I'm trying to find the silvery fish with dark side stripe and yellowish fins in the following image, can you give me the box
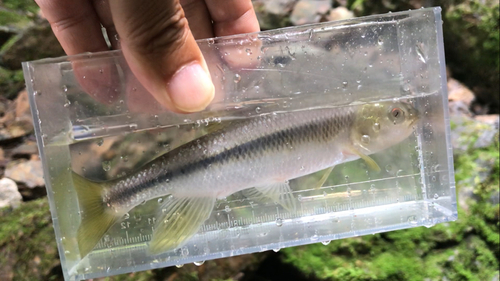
[72,101,419,257]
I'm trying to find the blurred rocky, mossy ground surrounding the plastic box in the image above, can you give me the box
[0,0,500,281]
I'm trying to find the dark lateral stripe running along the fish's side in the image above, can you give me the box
[106,109,355,202]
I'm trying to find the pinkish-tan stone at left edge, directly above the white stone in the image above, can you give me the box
[5,159,45,188]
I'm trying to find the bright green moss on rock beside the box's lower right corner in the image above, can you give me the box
[282,131,500,281]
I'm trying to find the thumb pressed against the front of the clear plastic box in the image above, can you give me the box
[109,0,214,112]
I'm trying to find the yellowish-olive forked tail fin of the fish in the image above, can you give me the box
[73,172,120,258]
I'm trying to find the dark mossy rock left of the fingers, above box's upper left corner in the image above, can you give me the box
[0,20,64,70]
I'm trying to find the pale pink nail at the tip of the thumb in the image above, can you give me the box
[167,63,215,112]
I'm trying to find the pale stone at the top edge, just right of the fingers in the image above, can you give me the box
[290,0,332,25]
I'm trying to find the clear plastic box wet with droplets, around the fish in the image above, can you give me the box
[23,8,457,280]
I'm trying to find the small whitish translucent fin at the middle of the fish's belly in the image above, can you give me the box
[246,182,296,212]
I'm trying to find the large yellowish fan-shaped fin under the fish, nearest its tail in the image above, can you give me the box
[149,197,215,254]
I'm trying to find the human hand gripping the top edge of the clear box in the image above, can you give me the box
[35,0,259,112]
